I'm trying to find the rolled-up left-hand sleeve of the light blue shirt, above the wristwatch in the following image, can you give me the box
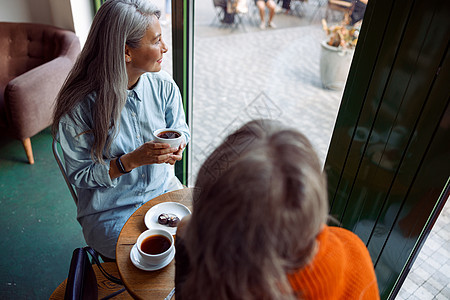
[59,122,118,189]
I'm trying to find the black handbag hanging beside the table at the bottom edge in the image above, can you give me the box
[64,247,125,300]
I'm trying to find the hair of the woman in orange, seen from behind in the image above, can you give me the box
[177,120,328,300]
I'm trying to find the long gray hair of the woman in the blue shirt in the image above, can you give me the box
[52,0,161,163]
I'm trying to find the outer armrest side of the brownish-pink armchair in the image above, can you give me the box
[4,56,73,140]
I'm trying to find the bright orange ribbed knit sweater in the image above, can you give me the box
[288,226,380,300]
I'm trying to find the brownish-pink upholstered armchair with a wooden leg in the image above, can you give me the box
[0,22,80,164]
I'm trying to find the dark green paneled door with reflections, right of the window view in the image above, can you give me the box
[325,0,450,299]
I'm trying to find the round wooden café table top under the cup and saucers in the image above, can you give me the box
[116,188,193,300]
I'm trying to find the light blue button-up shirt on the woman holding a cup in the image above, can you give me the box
[59,71,190,258]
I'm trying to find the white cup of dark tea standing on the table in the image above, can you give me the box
[136,228,175,265]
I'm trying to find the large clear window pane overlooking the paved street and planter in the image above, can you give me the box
[190,0,366,179]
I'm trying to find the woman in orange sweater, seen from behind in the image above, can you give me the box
[175,120,379,300]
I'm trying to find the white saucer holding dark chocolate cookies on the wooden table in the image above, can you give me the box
[144,202,191,235]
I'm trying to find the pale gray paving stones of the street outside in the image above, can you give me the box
[156,0,450,300]
